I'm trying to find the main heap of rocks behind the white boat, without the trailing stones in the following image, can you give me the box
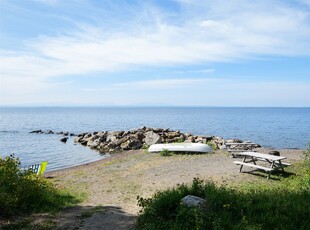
[74,127,224,153]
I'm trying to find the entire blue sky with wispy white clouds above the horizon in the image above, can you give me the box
[0,0,310,107]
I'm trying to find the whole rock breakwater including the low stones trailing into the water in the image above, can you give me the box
[30,127,261,153]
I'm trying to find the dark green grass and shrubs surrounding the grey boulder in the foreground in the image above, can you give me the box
[136,146,310,229]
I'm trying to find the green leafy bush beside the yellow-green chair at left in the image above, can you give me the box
[0,155,79,217]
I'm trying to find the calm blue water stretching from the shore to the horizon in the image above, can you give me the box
[0,107,310,171]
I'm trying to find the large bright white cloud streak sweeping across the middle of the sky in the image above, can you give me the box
[1,1,310,81]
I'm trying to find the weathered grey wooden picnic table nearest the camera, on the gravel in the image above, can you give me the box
[234,152,291,179]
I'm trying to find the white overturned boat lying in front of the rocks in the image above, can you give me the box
[148,143,213,153]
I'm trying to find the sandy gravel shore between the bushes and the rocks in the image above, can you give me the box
[38,149,302,229]
